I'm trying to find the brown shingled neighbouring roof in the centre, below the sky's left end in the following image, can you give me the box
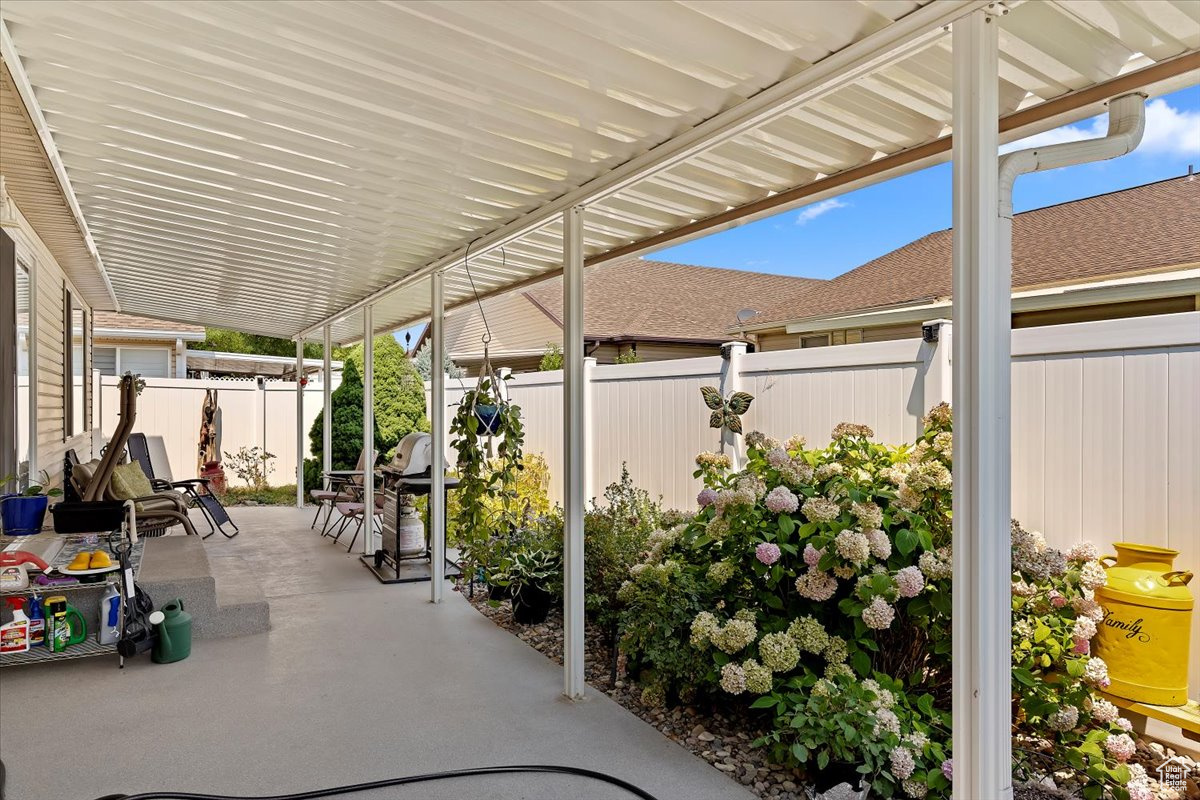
[524,258,824,341]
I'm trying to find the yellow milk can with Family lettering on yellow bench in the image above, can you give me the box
[1094,543,1193,705]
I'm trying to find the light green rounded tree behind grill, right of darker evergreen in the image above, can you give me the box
[333,335,430,455]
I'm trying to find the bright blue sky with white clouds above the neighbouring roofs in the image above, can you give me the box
[648,86,1200,278]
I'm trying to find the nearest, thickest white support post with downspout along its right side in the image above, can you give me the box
[952,11,1013,800]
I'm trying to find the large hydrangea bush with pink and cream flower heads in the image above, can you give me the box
[619,404,1147,800]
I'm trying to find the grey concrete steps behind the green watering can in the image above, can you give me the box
[138,536,271,639]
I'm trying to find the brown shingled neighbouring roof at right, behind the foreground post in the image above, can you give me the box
[734,176,1200,329]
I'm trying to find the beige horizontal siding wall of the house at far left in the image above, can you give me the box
[11,200,92,485]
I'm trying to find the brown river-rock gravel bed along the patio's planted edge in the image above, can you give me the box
[460,587,1200,800]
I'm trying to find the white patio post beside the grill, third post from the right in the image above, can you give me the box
[430,272,446,603]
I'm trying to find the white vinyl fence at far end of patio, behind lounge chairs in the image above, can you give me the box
[97,375,331,486]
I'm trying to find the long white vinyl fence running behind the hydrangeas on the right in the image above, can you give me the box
[436,313,1200,700]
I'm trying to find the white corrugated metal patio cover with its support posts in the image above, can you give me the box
[0,0,1200,798]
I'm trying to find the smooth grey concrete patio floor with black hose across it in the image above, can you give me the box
[0,507,752,800]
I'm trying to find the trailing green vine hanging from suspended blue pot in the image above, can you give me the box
[450,374,524,578]
